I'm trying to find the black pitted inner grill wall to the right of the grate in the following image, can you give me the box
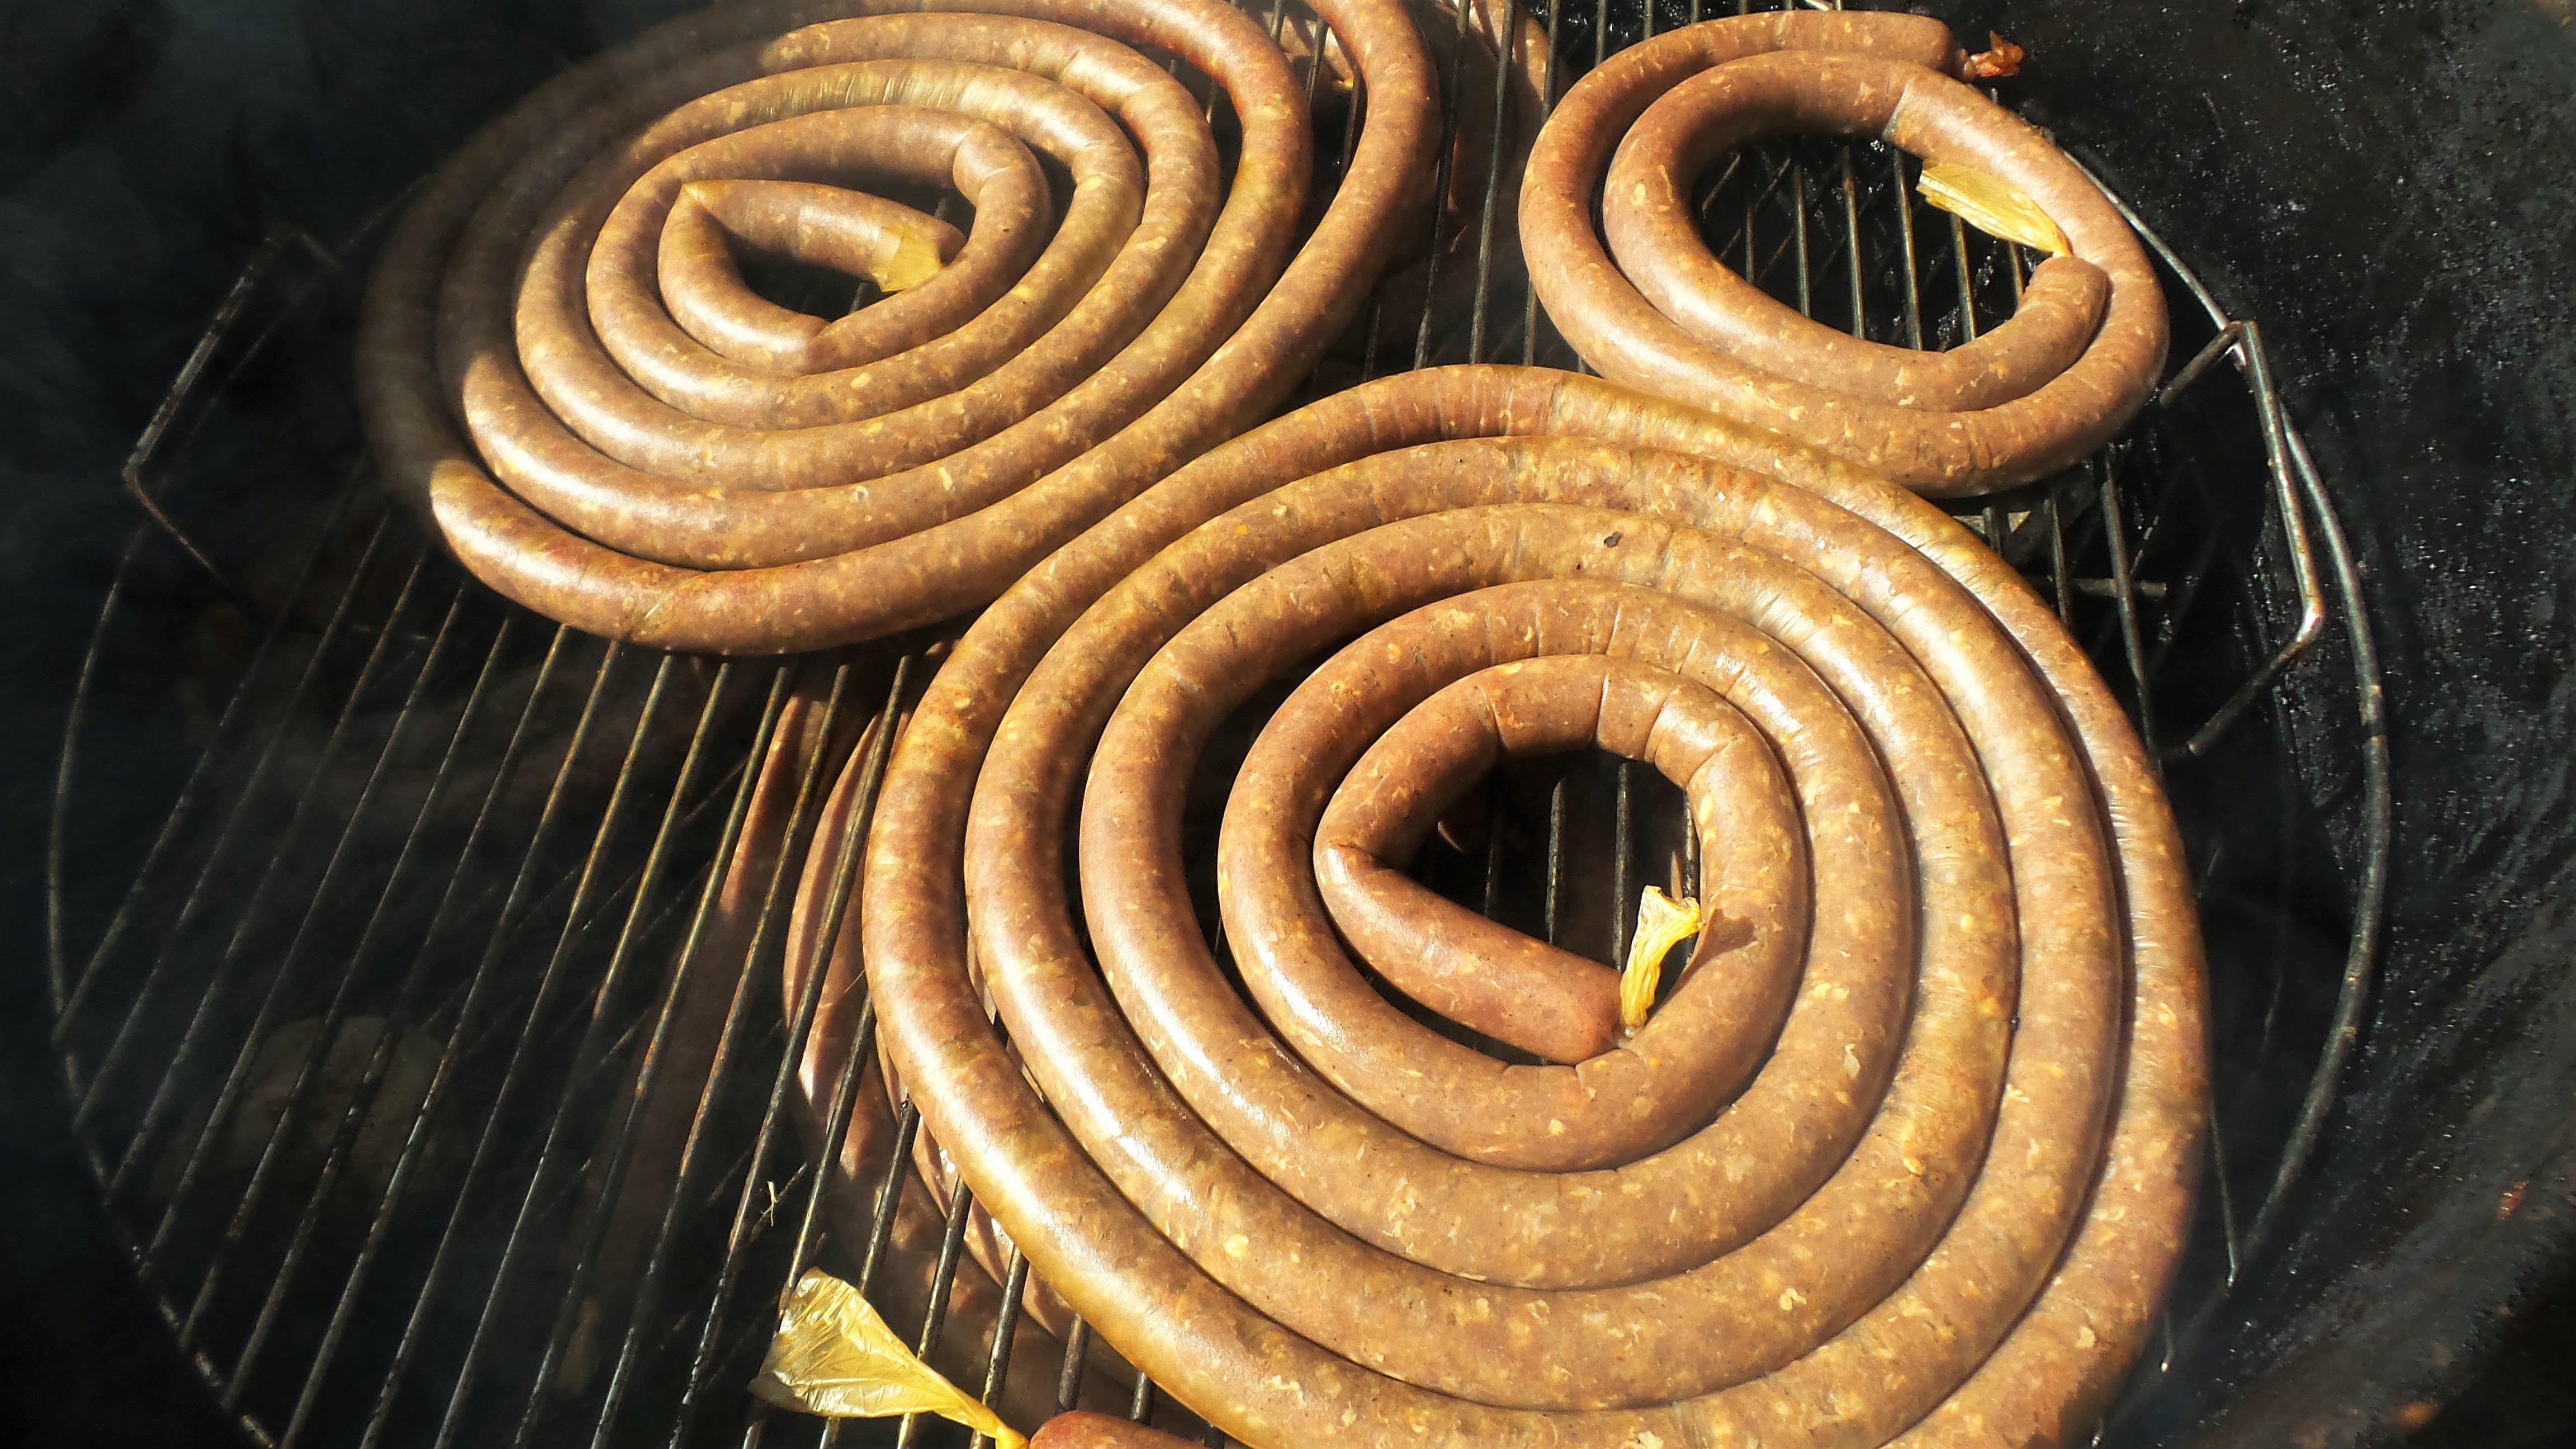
[1924,0,2576,1446]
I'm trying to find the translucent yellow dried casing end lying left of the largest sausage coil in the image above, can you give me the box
[752,1268,1028,1449]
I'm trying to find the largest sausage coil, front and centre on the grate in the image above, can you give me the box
[858,366,2205,1449]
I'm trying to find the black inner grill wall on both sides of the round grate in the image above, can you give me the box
[0,0,2576,1446]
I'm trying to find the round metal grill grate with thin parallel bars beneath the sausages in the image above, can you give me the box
[49,0,2388,1449]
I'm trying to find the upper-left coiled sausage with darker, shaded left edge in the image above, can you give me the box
[358,0,1437,652]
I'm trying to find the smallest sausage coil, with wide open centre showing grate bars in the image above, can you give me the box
[1520,10,2166,498]
